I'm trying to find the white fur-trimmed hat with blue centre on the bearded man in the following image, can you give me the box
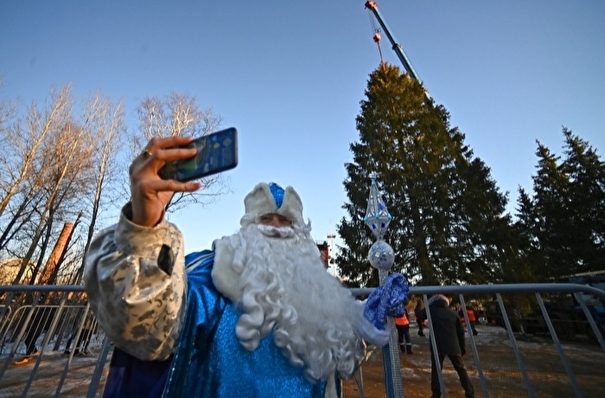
[244,182,303,224]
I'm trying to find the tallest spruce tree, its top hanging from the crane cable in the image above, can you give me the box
[337,64,510,286]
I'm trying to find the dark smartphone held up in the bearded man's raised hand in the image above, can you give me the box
[159,127,237,182]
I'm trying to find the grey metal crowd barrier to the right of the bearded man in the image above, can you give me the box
[352,283,605,398]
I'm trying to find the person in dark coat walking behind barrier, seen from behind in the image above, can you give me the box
[424,294,475,398]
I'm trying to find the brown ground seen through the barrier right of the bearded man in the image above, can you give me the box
[343,326,605,398]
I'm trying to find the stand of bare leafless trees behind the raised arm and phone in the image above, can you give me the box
[0,85,225,290]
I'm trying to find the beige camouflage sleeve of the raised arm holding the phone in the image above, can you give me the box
[84,205,186,360]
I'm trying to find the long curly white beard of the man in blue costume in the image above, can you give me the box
[232,223,364,381]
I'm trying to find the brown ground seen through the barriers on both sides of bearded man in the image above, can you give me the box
[0,326,605,398]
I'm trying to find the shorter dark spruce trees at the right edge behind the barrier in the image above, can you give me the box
[517,129,605,281]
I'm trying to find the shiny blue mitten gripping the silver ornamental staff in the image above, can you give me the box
[363,272,410,330]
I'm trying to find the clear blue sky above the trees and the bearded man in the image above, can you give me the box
[0,0,605,251]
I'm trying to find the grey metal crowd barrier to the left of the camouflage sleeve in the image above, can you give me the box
[0,285,109,398]
